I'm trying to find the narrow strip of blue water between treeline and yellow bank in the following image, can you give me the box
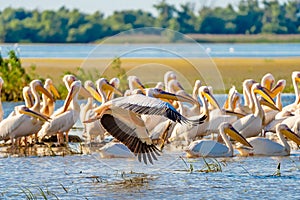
[0,43,300,58]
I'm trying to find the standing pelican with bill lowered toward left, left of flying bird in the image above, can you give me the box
[38,81,82,144]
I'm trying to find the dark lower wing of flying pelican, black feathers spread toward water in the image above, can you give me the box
[101,114,160,164]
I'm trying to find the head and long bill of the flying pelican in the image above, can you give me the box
[146,88,197,104]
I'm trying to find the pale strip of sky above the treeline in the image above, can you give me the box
[0,0,286,16]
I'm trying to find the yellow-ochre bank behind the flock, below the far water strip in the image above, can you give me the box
[21,57,300,93]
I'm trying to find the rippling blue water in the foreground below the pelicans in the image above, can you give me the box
[0,94,300,199]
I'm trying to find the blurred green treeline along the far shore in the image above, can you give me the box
[0,0,300,43]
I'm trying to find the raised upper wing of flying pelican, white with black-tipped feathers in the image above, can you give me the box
[112,94,206,125]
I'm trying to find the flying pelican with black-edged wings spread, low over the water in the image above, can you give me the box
[86,88,206,164]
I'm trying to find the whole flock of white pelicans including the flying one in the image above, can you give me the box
[0,71,300,164]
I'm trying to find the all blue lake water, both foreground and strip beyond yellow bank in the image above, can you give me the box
[0,41,300,199]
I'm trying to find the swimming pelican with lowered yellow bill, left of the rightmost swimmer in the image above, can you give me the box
[185,122,251,157]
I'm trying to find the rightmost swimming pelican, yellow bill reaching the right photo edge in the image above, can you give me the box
[237,124,300,156]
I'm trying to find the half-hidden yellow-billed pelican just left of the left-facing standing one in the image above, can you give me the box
[41,78,60,117]
